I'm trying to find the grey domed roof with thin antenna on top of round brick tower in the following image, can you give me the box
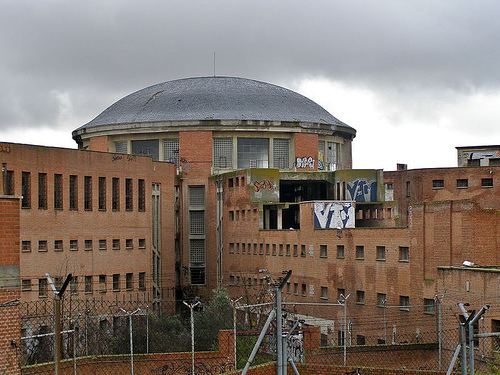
[74,77,356,135]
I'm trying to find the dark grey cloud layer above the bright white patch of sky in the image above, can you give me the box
[0,0,500,128]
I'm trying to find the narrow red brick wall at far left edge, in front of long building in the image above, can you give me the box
[0,196,21,375]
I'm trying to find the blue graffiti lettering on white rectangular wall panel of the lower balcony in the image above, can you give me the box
[314,202,355,229]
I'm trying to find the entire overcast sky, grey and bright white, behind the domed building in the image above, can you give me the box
[0,0,500,169]
